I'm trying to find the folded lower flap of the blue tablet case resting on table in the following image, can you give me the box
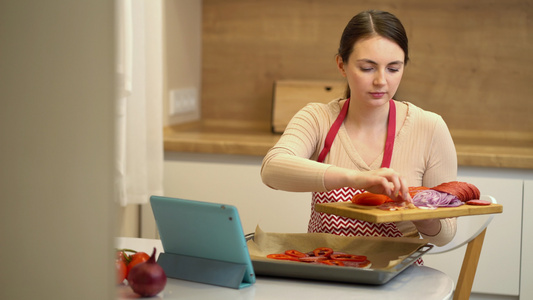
[157,252,249,289]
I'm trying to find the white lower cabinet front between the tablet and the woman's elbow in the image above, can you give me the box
[164,152,311,233]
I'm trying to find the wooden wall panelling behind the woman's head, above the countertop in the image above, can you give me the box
[202,0,533,132]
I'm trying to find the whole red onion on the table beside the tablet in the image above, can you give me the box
[128,248,167,297]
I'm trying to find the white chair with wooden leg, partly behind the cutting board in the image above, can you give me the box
[427,195,497,300]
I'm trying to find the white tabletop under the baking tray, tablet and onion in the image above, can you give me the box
[117,238,454,300]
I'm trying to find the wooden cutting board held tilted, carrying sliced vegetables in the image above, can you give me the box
[315,202,503,223]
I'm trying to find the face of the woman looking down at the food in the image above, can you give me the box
[337,36,405,106]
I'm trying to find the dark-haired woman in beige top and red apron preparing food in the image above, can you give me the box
[261,10,457,246]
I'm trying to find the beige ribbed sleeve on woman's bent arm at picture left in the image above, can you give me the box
[261,104,331,192]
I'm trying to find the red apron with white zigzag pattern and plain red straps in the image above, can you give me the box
[308,99,423,265]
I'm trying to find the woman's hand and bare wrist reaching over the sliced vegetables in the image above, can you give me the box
[325,167,412,202]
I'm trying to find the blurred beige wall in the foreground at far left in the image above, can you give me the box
[0,0,115,300]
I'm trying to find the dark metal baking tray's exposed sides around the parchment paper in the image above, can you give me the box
[246,233,433,285]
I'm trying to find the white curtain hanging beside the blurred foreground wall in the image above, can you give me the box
[115,0,163,206]
